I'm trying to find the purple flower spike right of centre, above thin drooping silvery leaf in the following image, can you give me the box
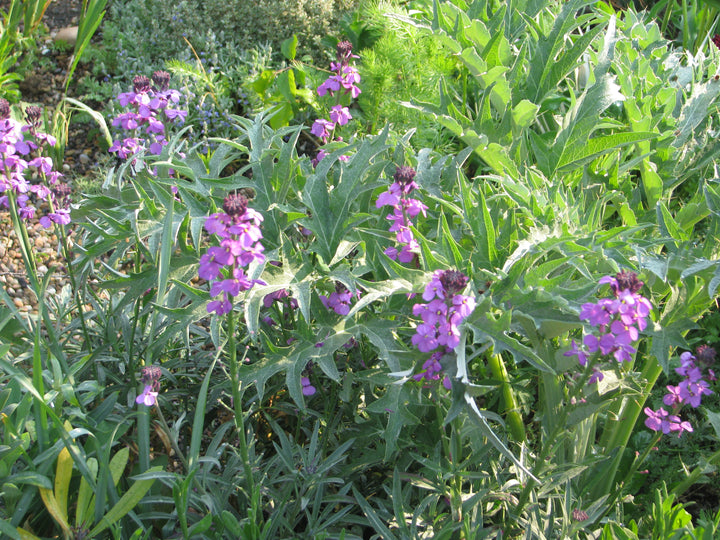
[412,270,475,387]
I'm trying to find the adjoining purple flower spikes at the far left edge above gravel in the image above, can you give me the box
[0,98,71,228]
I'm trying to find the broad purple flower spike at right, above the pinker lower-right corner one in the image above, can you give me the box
[565,271,652,384]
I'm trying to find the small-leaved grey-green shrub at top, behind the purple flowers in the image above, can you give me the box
[94,0,357,103]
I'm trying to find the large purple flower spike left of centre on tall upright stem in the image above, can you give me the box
[198,194,265,315]
